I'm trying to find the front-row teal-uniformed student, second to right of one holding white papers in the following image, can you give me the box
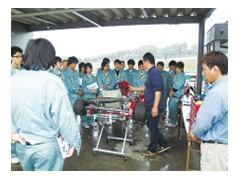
[112,59,127,88]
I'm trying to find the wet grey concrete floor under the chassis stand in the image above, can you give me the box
[11,121,200,171]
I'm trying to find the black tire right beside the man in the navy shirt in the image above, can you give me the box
[133,102,146,123]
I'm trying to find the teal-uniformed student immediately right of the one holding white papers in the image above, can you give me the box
[97,61,115,95]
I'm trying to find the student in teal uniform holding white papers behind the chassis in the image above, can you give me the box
[81,63,98,128]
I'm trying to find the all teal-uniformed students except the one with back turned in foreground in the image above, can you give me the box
[11,40,185,166]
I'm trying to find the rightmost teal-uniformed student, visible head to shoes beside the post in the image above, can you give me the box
[165,61,186,127]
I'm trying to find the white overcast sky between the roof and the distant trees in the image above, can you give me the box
[34,24,198,58]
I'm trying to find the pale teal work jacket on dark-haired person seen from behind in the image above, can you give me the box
[11,70,81,153]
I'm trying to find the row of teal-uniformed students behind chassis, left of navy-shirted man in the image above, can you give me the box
[50,56,147,128]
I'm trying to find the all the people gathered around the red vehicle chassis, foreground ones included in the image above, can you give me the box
[11,38,228,170]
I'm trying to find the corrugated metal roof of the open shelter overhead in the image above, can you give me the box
[11,8,214,31]
